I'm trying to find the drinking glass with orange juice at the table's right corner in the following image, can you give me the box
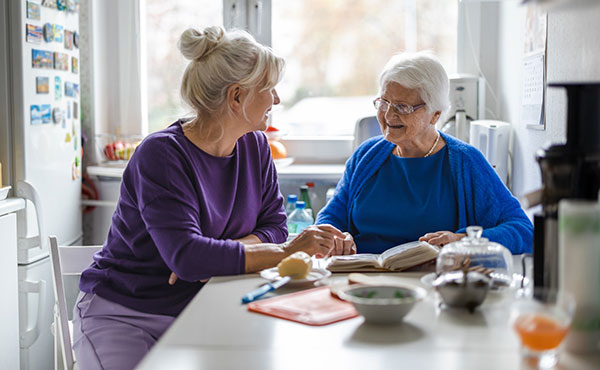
[511,288,575,369]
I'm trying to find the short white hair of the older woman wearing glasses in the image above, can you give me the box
[379,51,450,112]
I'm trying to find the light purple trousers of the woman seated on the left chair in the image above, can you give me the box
[73,292,175,370]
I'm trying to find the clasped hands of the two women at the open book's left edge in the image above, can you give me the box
[284,225,346,258]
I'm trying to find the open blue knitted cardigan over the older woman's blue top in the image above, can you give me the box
[316,133,533,254]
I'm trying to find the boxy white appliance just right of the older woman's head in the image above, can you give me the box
[441,73,485,142]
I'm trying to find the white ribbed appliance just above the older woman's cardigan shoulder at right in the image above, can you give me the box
[469,120,511,185]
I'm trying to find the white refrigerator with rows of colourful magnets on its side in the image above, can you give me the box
[0,0,82,370]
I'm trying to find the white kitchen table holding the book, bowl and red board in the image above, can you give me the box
[138,264,600,370]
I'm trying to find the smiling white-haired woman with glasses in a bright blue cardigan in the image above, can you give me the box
[317,53,533,254]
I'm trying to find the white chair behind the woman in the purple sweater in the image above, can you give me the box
[48,236,102,370]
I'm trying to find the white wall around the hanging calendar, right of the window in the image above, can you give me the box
[498,2,600,195]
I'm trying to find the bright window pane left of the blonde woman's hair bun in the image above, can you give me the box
[145,0,223,132]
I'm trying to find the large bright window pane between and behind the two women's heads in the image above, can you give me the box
[271,0,458,136]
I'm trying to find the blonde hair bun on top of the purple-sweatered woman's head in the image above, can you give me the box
[177,26,225,60]
